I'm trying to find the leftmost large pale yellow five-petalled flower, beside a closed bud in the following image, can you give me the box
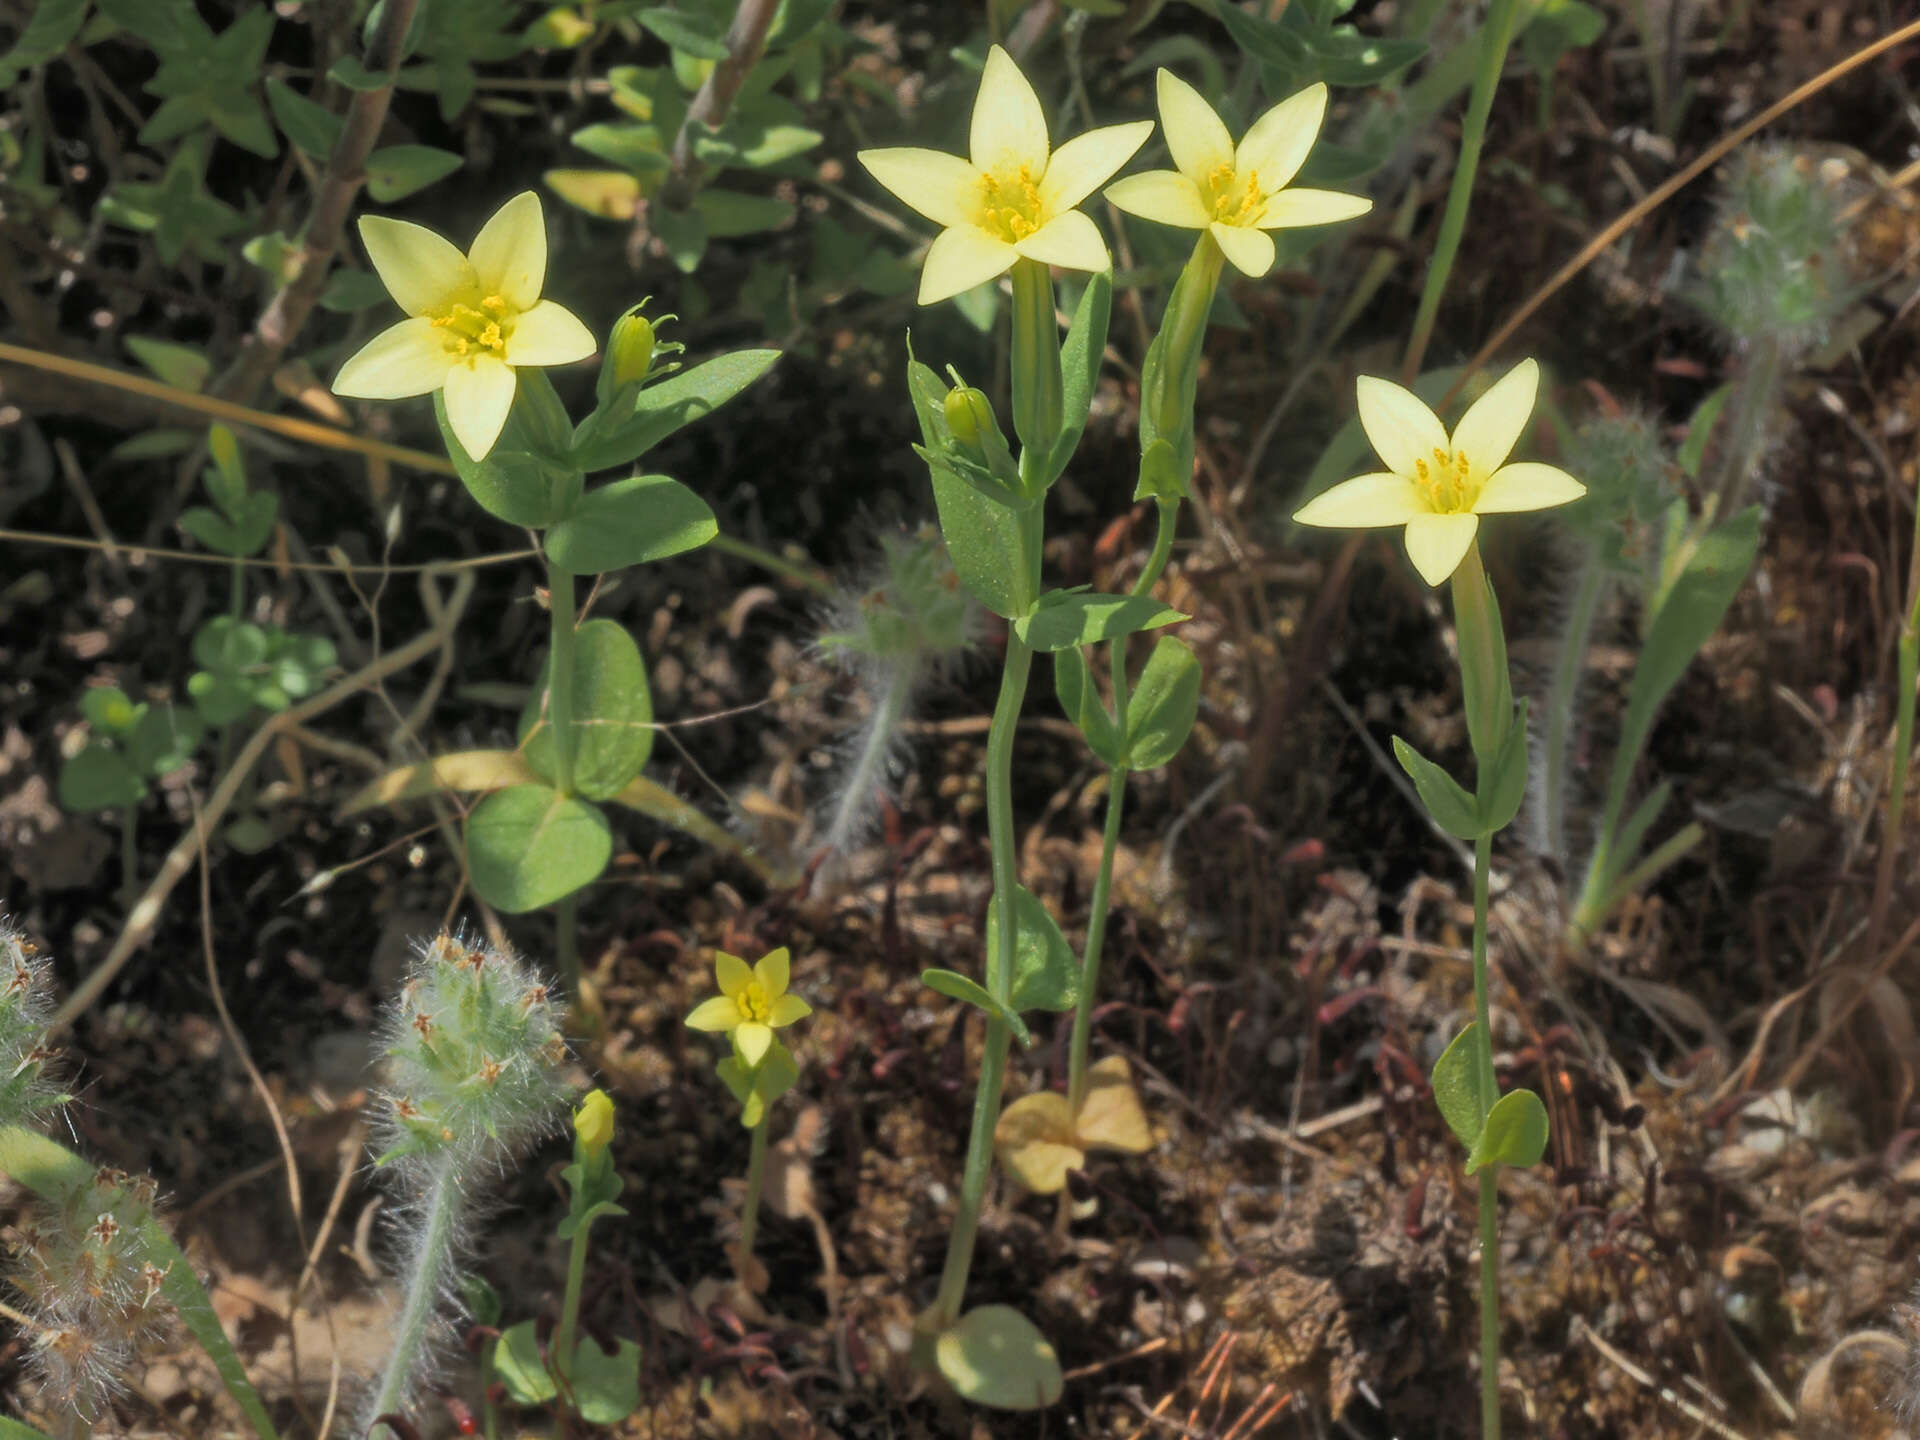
[334,190,593,459]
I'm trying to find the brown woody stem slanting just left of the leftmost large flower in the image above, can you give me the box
[213,0,417,403]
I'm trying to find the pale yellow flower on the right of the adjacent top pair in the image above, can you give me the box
[1106,69,1373,278]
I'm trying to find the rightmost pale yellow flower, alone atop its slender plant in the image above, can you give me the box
[1294,359,1586,586]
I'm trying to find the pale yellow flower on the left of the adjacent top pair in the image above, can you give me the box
[860,46,1154,305]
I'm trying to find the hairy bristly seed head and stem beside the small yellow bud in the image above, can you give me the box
[359,933,566,1440]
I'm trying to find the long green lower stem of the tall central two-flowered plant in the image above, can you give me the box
[933,634,1033,1329]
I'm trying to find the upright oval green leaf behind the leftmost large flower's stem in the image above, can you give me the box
[520,620,653,801]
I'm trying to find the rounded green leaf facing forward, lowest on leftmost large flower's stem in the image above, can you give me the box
[467,785,612,916]
